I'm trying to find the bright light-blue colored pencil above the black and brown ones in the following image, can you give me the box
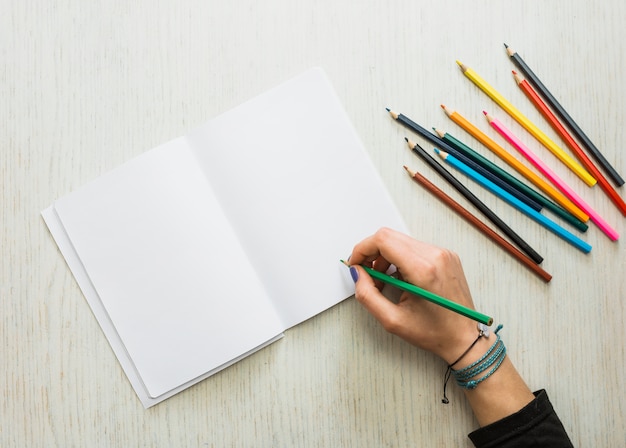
[435,149,591,253]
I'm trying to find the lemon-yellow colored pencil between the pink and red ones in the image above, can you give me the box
[456,61,596,187]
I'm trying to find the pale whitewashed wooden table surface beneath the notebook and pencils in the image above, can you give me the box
[0,0,626,447]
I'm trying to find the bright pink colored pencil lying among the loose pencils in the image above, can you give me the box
[483,111,619,241]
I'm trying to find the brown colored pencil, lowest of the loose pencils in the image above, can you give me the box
[404,166,552,283]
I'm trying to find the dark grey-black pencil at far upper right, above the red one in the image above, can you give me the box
[504,44,624,186]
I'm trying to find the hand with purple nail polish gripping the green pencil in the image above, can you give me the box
[349,228,478,364]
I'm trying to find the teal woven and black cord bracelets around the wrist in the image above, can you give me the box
[441,324,506,404]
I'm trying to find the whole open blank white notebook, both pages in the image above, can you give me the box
[42,68,405,407]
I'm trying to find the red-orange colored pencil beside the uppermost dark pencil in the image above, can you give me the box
[513,71,626,216]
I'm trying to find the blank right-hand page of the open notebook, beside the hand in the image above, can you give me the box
[188,69,406,328]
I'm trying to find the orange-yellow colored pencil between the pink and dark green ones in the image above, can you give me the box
[441,104,589,222]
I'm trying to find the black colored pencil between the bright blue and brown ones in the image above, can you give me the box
[405,138,543,264]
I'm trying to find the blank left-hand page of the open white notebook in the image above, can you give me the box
[43,138,283,407]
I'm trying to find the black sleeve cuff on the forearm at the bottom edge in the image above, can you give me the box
[469,389,573,448]
